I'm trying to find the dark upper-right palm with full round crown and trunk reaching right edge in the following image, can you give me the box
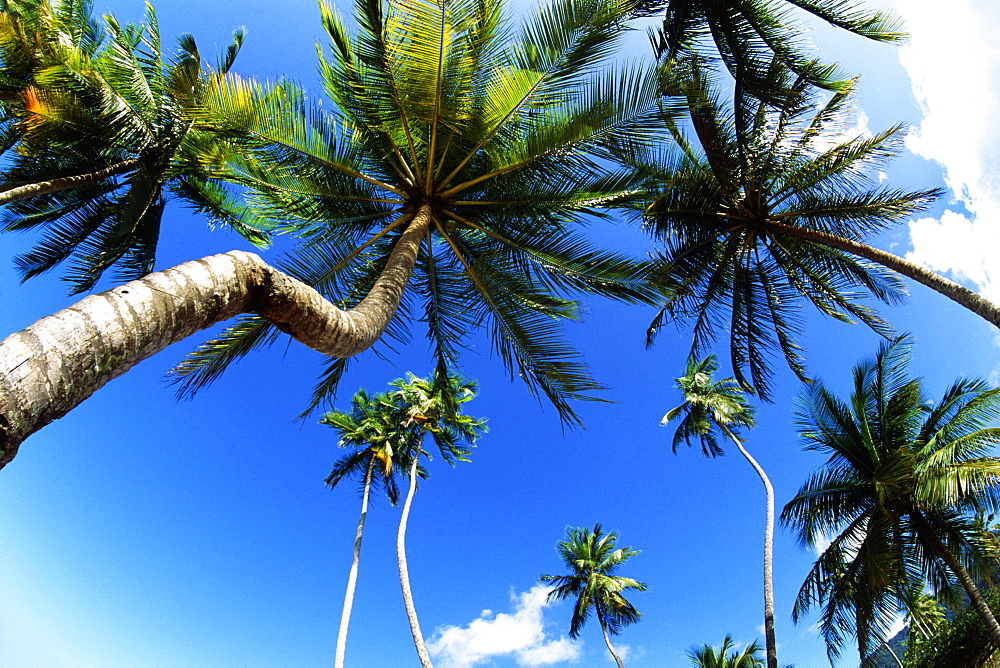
[638,59,1000,398]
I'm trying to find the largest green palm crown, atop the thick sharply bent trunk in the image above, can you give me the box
[170,0,662,420]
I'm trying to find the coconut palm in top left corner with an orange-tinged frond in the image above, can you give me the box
[0,0,273,292]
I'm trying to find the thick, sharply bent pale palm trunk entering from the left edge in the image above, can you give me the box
[0,206,430,468]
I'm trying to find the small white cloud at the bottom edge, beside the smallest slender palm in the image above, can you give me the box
[427,584,581,668]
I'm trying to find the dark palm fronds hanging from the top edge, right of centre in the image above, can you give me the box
[653,0,906,98]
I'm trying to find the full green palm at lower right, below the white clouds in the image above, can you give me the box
[781,337,1000,661]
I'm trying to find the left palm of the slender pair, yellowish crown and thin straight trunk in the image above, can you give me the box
[320,389,426,668]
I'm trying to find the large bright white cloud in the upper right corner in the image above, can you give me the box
[896,0,1000,300]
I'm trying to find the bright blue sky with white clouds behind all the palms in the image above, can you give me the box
[0,0,1000,668]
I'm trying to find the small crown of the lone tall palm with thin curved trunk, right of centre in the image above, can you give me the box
[660,355,754,457]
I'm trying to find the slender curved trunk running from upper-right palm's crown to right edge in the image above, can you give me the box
[768,222,1000,327]
